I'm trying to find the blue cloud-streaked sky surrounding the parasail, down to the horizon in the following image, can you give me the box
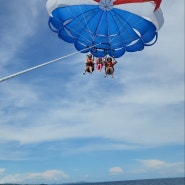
[0,0,184,184]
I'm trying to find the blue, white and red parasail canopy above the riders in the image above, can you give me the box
[46,0,164,58]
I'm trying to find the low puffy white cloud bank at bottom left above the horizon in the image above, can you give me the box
[0,170,69,183]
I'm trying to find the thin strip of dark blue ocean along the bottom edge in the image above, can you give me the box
[63,177,185,185]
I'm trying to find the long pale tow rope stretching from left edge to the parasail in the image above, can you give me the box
[0,46,97,83]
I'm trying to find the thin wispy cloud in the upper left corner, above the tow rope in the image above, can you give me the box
[0,1,44,68]
